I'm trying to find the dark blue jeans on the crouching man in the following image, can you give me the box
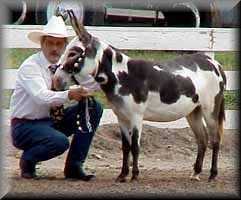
[11,99,103,164]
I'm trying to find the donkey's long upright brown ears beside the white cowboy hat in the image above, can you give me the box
[67,9,91,46]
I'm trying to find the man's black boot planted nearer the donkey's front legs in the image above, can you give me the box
[64,163,95,181]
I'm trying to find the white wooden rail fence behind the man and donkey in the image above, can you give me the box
[1,25,239,129]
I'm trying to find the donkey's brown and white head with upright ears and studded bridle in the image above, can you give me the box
[54,10,108,90]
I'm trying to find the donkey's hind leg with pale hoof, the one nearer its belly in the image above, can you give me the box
[187,107,208,181]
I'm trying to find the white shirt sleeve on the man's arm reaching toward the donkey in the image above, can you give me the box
[18,63,69,106]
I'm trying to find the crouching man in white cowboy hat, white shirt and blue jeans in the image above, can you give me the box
[10,16,102,181]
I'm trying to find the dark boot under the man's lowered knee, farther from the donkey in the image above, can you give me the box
[19,158,37,179]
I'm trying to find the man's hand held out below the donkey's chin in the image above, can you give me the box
[68,86,91,101]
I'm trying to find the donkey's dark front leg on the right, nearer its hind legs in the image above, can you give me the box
[131,127,140,181]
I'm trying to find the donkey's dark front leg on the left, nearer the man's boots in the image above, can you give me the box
[116,128,131,182]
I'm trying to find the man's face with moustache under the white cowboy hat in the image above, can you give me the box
[41,36,67,64]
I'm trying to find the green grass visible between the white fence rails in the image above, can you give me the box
[1,49,240,110]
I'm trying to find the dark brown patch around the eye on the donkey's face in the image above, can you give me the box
[63,46,83,72]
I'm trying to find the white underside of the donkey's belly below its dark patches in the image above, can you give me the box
[144,93,199,122]
